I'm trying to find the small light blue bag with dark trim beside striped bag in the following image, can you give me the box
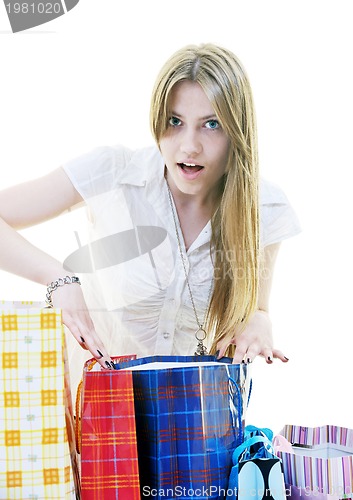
[227,425,286,500]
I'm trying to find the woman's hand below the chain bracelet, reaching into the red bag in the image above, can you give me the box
[52,283,114,370]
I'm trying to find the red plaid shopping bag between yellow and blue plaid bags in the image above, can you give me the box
[76,356,140,500]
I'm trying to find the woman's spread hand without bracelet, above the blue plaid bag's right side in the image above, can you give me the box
[217,310,288,364]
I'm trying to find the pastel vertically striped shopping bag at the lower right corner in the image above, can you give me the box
[276,425,353,500]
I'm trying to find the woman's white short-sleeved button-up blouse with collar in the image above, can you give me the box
[64,146,300,378]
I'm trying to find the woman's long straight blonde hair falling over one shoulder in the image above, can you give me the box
[150,44,259,355]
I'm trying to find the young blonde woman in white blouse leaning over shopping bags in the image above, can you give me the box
[0,44,299,386]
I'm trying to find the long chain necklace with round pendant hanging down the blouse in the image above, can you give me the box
[166,179,213,356]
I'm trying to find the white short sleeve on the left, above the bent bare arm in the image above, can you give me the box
[63,146,132,200]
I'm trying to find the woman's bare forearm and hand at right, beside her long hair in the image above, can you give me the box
[217,243,288,363]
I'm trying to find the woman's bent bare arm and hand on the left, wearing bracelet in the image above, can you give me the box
[0,168,111,368]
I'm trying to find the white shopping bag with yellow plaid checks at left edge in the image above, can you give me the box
[0,301,79,500]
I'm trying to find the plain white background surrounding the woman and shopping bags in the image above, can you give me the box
[0,0,353,432]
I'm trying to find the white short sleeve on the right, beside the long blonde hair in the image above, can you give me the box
[260,179,301,247]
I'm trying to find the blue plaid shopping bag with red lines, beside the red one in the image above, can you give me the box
[113,356,250,500]
